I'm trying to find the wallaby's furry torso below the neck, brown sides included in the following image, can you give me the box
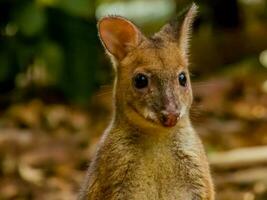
[84,126,214,200]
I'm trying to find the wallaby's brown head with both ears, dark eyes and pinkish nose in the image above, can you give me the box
[98,4,197,128]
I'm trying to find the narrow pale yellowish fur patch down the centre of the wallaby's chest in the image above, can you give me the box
[121,141,195,200]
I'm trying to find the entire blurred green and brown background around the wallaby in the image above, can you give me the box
[0,0,267,200]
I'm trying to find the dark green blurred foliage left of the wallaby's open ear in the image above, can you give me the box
[0,0,108,102]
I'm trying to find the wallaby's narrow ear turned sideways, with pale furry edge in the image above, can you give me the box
[160,3,197,58]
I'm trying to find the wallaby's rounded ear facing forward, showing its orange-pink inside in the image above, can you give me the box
[98,16,142,60]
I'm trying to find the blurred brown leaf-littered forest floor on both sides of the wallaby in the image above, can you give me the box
[0,61,267,200]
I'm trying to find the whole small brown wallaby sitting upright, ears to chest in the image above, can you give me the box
[79,4,214,200]
